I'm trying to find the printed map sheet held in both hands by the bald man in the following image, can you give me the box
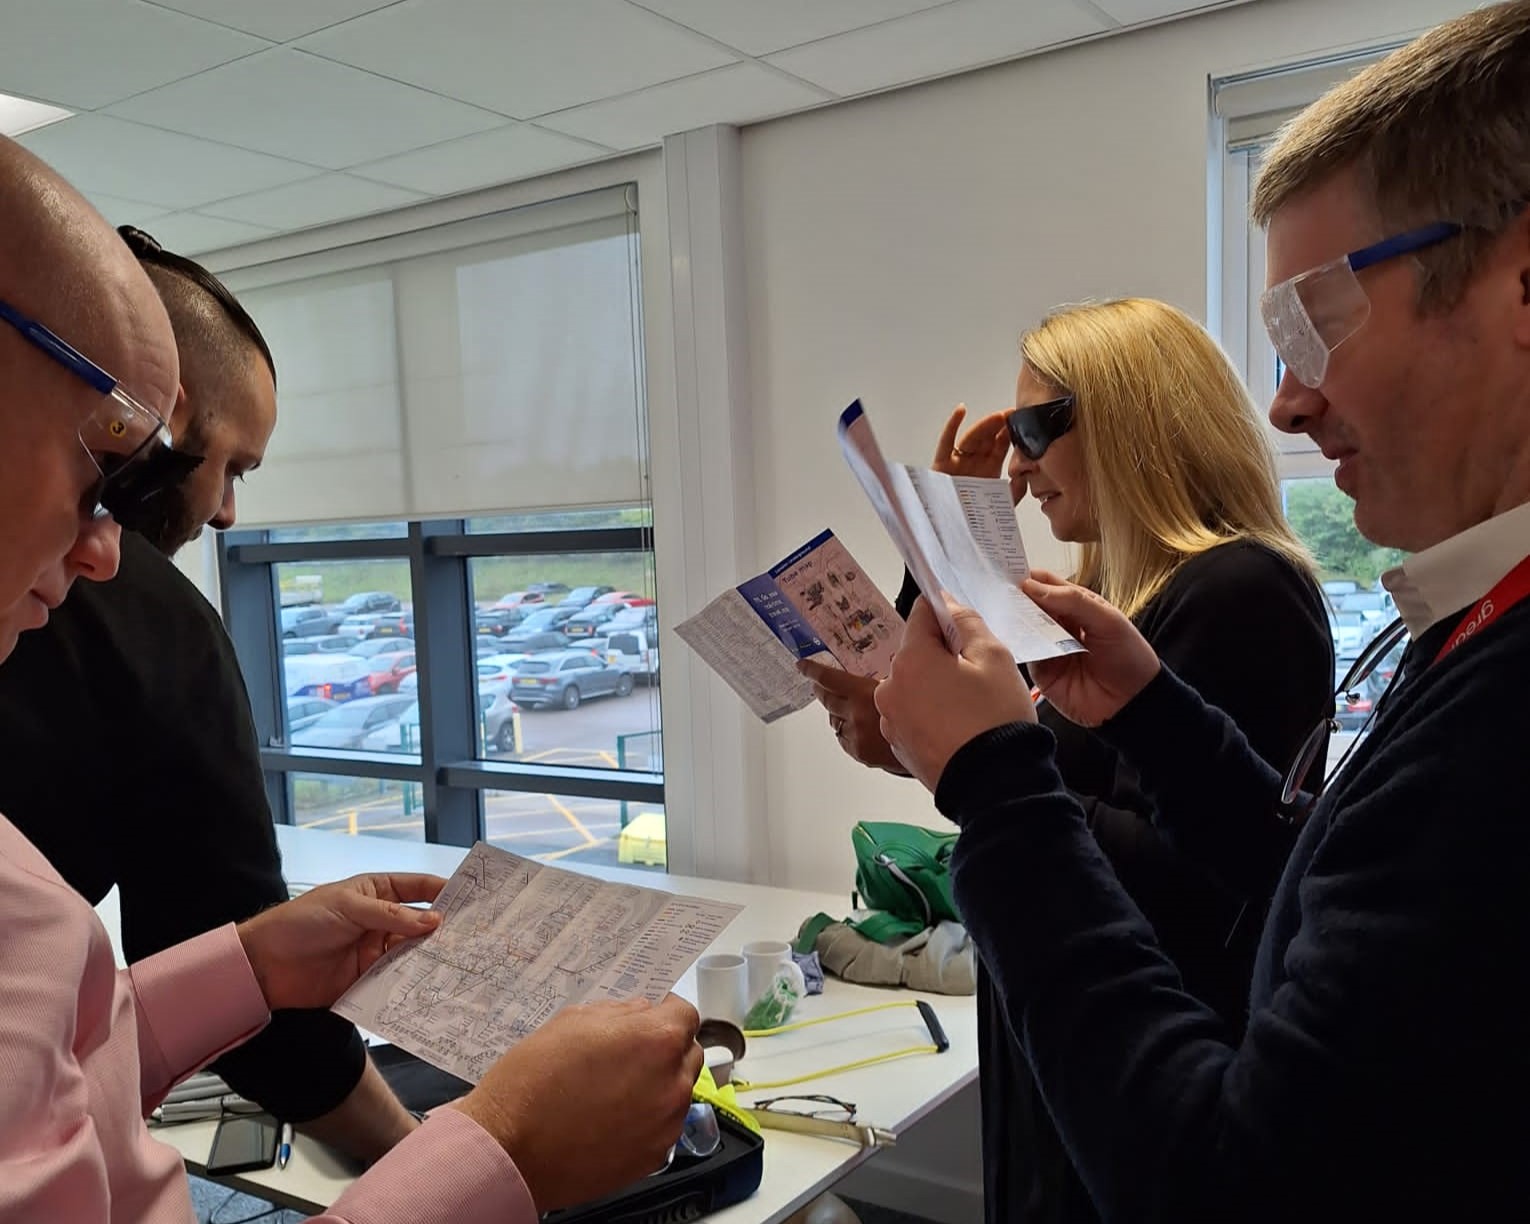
[334,842,741,1083]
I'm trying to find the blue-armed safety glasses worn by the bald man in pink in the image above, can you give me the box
[0,301,175,519]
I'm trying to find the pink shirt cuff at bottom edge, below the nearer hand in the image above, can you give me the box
[314,1109,537,1224]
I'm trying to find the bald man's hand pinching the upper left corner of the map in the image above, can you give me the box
[239,874,447,1011]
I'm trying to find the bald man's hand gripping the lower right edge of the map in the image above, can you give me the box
[454,995,701,1212]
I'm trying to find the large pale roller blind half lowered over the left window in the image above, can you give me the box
[226,190,647,526]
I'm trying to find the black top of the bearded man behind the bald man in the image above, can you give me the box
[0,531,366,1121]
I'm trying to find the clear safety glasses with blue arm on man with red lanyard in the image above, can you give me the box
[1259,220,1464,387]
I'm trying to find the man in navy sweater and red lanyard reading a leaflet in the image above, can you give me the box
[877,0,1530,1221]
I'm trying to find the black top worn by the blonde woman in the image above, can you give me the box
[898,542,1334,1224]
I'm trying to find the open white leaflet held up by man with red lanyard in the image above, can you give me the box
[838,399,1083,662]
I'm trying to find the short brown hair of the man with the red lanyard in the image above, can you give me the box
[1250,0,1530,312]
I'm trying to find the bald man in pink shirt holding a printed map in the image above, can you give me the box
[0,129,701,1224]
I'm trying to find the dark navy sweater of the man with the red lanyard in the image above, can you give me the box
[936,603,1530,1222]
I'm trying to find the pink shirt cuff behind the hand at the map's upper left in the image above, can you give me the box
[122,923,271,1114]
